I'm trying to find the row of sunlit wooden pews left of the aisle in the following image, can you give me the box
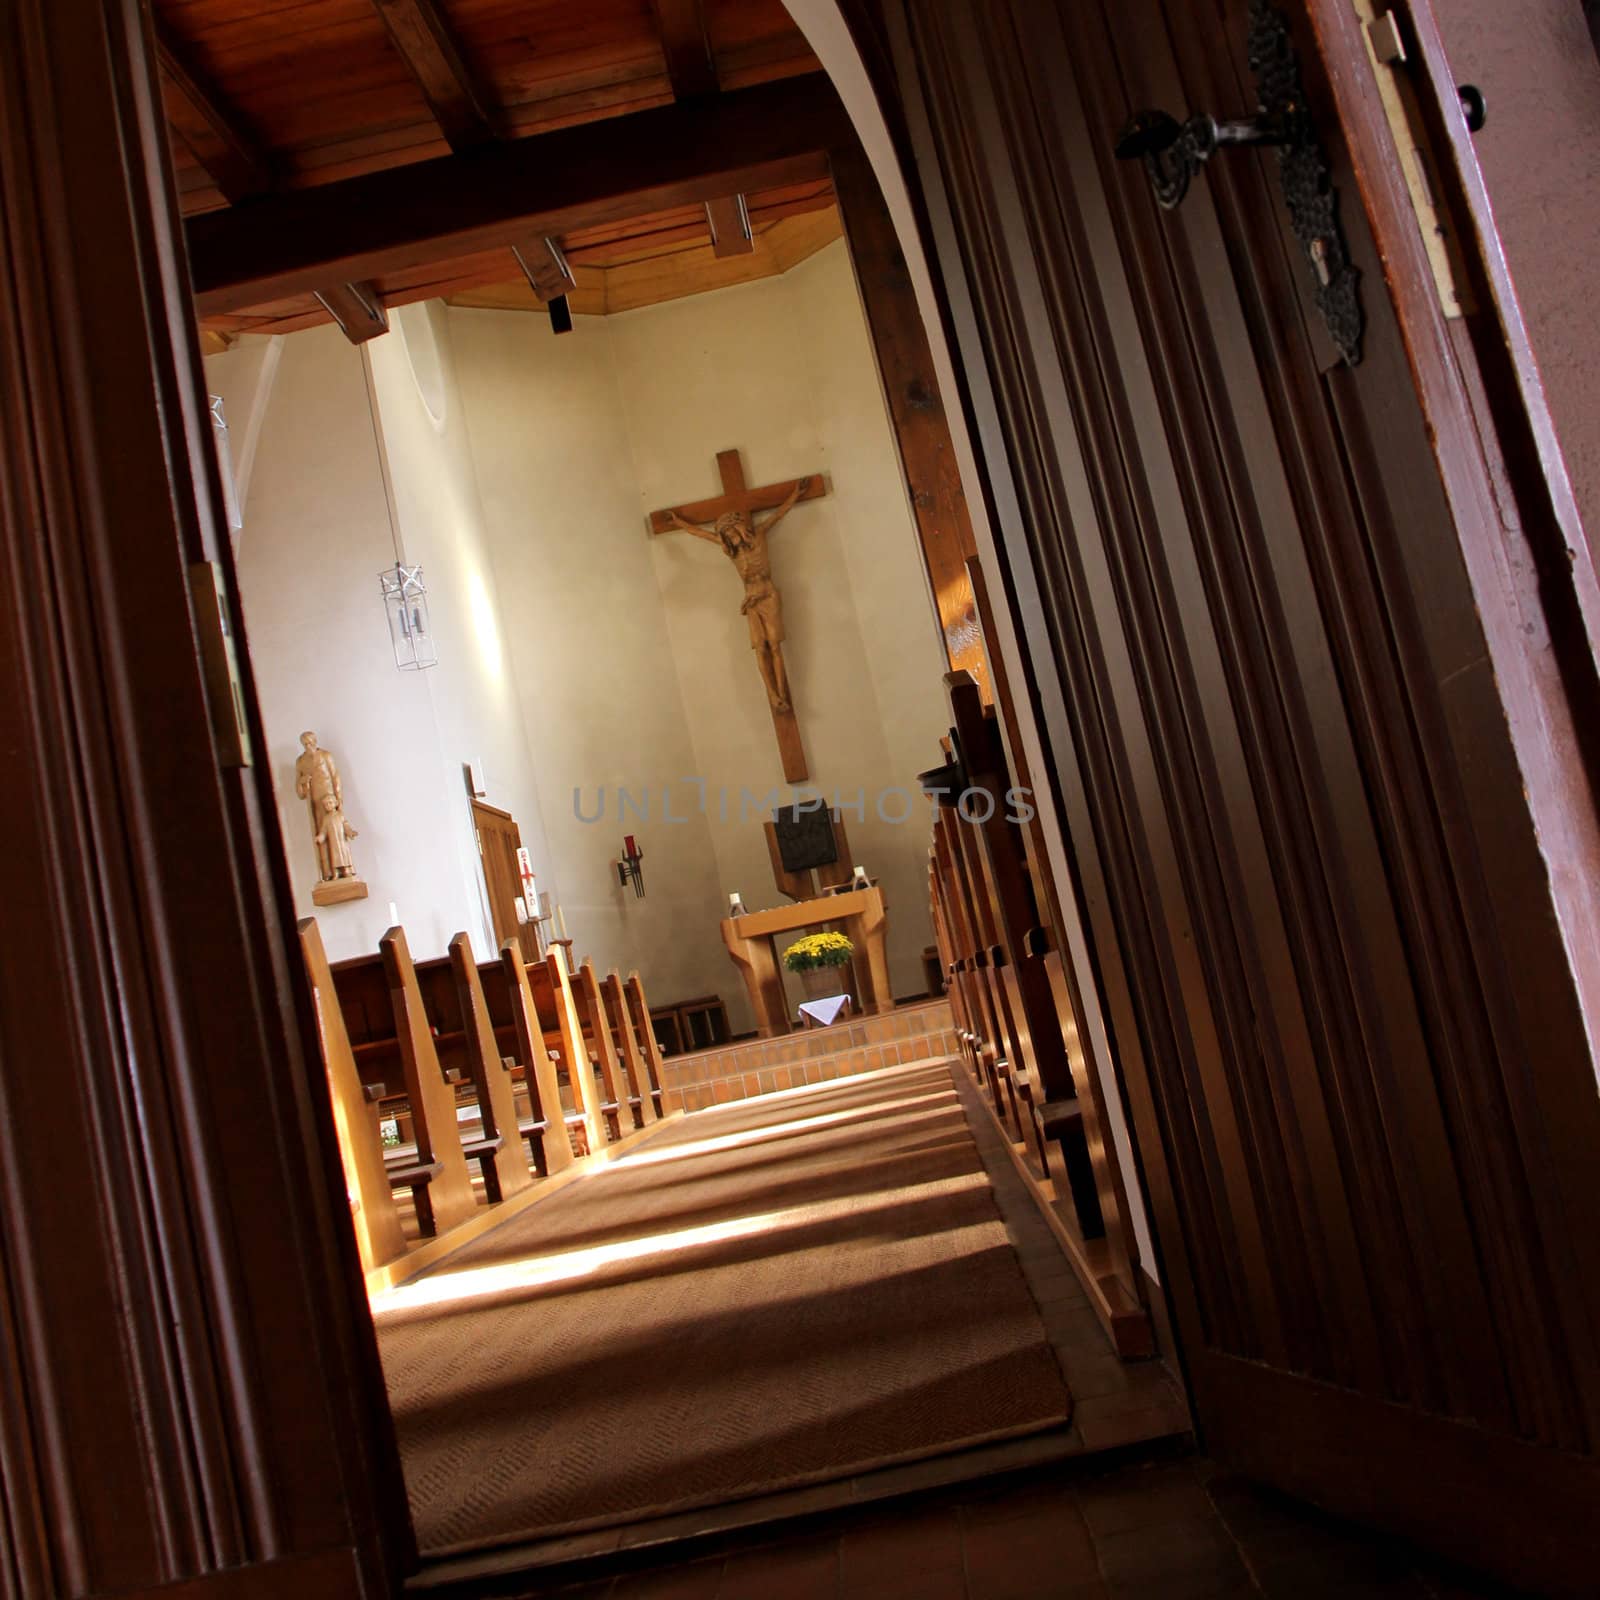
[299,917,664,1270]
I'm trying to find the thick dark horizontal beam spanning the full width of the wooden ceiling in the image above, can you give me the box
[186,74,853,315]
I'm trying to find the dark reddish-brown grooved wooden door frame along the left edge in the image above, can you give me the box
[0,0,413,1600]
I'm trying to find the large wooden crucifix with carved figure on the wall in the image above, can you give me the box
[650,450,827,784]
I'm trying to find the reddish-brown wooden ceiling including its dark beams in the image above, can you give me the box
[155,0,838,347]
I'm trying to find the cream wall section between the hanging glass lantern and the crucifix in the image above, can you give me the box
[450,310,732,1022]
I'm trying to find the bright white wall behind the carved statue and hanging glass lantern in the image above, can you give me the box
[208,309,542,960]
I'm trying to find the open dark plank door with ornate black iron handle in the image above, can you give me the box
[864,0,1600,1586]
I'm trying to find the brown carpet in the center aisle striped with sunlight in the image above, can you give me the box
[373,1062,1072,1555]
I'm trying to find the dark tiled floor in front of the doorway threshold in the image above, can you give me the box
[496,1459,1506,1600]
